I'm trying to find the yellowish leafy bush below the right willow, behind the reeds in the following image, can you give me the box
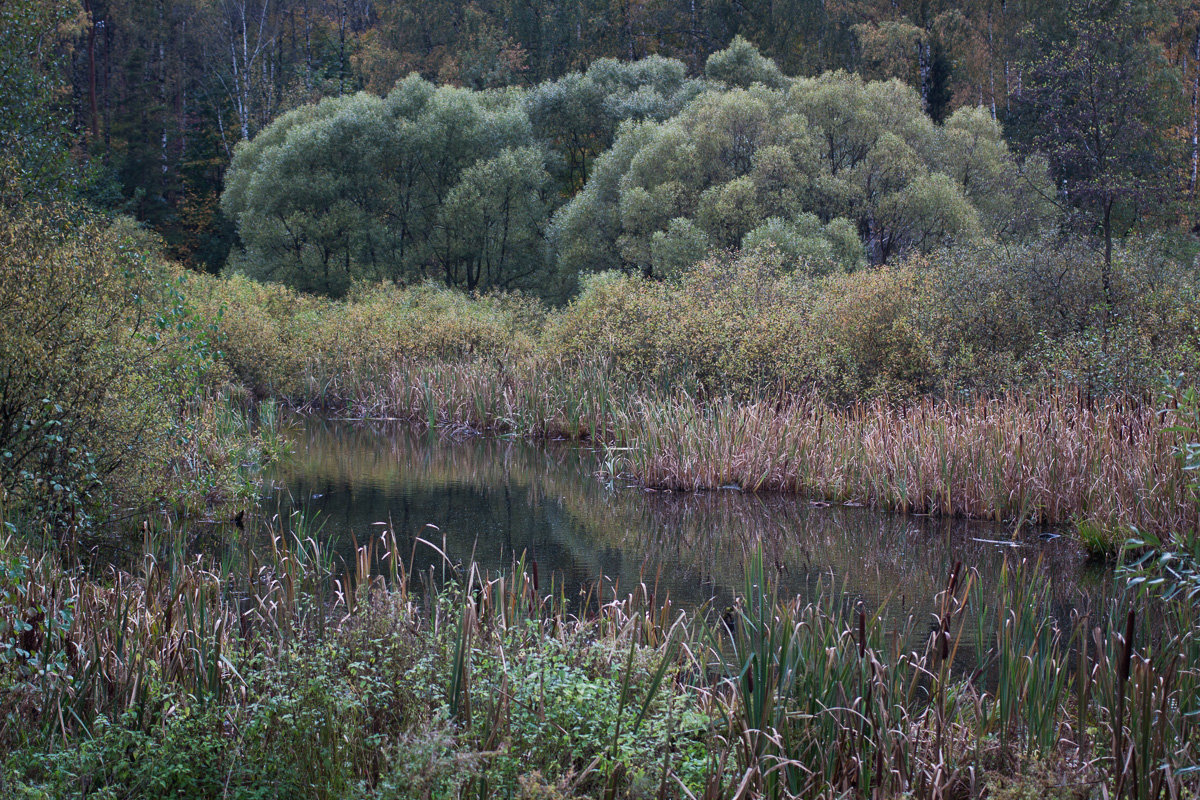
[544,251,925,399]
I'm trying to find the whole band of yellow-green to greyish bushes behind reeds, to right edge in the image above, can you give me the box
[540,237,1200,401]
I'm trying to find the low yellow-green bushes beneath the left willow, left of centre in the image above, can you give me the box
[184,276,546,404]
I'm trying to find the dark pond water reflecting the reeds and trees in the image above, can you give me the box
[267,417,1112,633]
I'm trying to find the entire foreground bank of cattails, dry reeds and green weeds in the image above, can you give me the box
[0,515,1200,800]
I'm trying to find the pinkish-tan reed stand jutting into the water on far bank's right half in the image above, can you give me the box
[626,395,1200,531]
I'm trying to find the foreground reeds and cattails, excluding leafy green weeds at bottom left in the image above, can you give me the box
[0,513,1200,798]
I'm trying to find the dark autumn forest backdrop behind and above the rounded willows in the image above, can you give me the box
[2,0,1200,271]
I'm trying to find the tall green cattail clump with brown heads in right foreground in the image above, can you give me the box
[709,563,1198,798]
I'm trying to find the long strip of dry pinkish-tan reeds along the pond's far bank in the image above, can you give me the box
[343,360,1200,547]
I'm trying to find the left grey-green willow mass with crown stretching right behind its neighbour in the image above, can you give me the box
[222,59,696,299]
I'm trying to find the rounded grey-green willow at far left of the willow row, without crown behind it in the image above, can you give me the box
[222,77,547,295]
